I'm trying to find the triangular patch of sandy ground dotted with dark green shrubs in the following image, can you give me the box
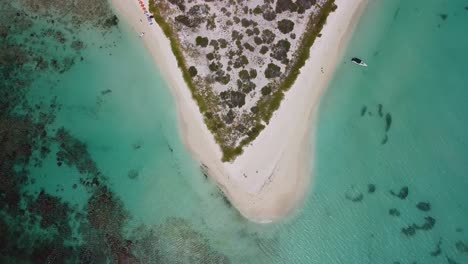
[150,0,336,161]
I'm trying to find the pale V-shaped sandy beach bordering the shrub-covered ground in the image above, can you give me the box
[111,0,368,223]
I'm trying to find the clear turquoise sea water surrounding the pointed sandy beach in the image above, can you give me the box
[0,0,468,264]
